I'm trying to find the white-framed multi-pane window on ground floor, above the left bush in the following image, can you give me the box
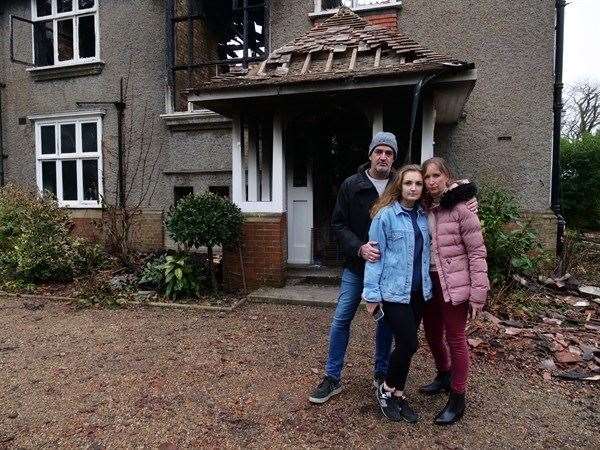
[35,116,102,208]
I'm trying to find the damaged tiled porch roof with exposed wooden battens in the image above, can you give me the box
[190,7,473,93]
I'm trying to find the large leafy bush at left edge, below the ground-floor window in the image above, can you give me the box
[0,185,103,283]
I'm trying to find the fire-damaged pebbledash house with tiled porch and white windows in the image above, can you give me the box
[0,0,556,286]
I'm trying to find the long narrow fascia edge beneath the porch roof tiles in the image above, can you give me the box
[188,70,477,102]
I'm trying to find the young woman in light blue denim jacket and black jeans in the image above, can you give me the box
[363,165,432,423]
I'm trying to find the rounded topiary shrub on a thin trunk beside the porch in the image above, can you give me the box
[166,193,244,290]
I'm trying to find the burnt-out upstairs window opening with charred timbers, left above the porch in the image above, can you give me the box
[168,0,268,111]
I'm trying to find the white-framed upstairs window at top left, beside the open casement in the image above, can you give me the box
[31,0,100,67]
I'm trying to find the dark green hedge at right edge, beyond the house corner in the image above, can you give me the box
[560,134,600,230]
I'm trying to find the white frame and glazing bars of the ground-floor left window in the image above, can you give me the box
[30,112,104,208]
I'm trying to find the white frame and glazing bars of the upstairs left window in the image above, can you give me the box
[31,0,100,68]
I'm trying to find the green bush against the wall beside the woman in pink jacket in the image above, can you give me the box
[479,188,545,285]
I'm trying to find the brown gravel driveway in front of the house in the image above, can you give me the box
[0,298,600,449]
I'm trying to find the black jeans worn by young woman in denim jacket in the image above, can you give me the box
[383,292,425,391]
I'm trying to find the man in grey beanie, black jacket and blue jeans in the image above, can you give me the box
[309,132,398,403]
